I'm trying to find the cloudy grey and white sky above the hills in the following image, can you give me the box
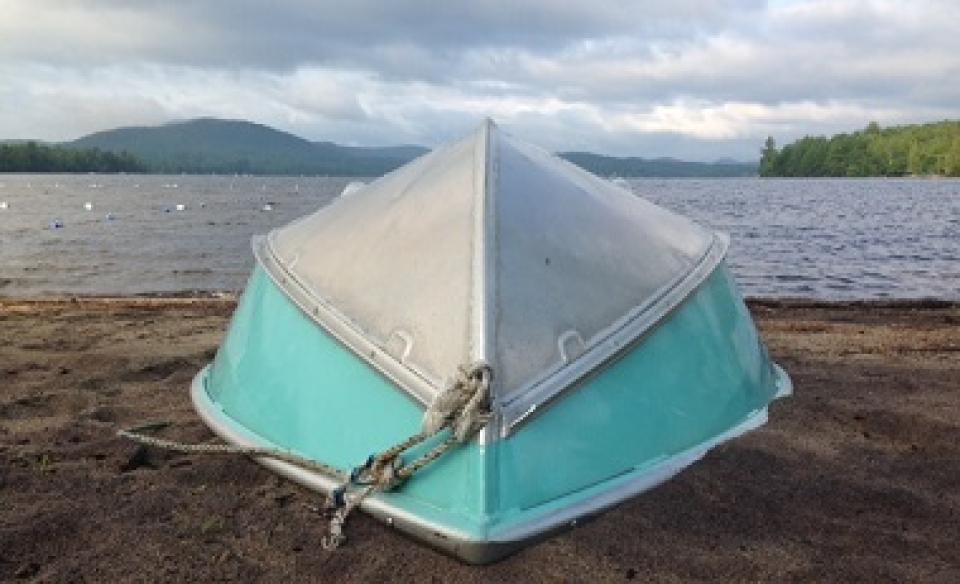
[0,0,960,160]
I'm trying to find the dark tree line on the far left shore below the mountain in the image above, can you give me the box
[0,142,147,173]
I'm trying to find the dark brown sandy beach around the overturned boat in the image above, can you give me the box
[0,299,960,583]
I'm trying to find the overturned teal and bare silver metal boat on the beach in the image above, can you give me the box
[192,121,790,563]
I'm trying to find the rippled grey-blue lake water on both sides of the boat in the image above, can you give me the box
[0,174,960,299]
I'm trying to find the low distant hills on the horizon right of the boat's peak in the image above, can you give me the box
[560,152,757,178]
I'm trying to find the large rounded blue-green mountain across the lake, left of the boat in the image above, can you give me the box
[64,118,427,176]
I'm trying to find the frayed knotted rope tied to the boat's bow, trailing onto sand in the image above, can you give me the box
[117,362,493,550]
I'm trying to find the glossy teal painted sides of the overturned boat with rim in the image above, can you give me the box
[194,264,790,562]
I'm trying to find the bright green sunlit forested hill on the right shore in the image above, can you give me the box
[760,121,960,177]
